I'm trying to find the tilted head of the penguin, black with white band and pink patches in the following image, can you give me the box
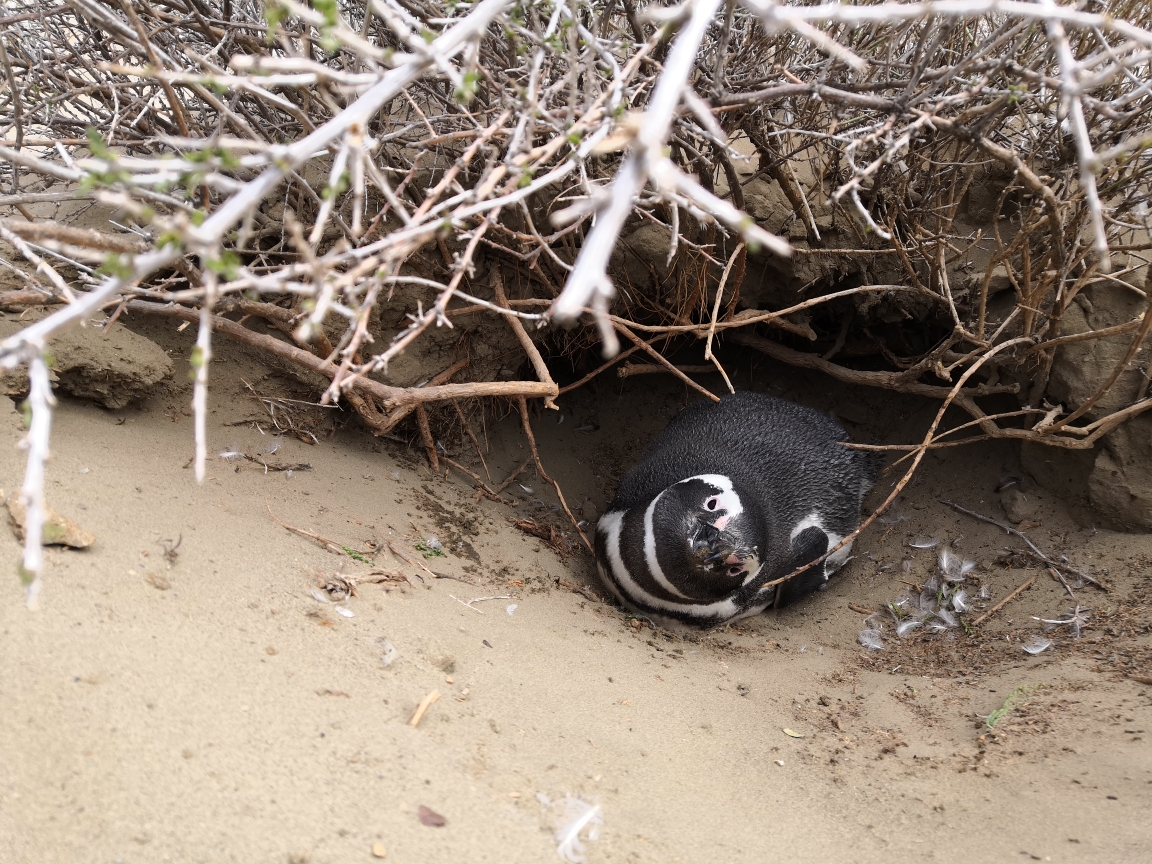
[652,475,760,599]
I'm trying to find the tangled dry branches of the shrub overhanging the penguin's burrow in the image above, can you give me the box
[0,0,1152,600]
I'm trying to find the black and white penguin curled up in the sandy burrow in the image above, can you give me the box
[596,393,880,628]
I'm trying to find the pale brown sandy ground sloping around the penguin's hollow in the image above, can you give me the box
[0,323,1152,864]
